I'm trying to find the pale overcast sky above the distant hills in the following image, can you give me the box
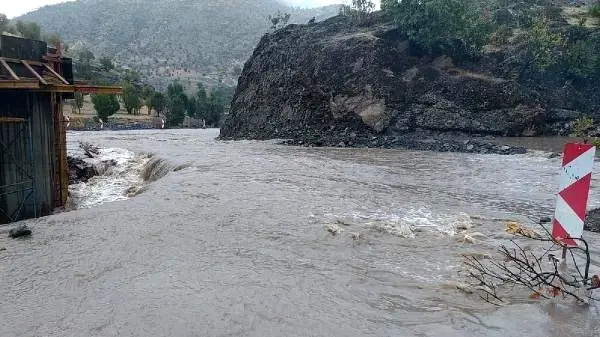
[0,0,379,18]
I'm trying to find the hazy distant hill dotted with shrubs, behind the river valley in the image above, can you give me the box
[17,0,338,87]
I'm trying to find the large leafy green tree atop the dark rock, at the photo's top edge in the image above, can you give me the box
[381,0,493,55]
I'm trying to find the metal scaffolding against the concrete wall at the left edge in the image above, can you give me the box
[0,117,40,224]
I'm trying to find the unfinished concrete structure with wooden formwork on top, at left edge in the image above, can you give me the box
[0,35,121,224]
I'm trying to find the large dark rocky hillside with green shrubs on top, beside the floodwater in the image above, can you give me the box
[221,0,600,154]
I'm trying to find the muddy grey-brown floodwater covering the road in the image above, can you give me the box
[0,130,600,337]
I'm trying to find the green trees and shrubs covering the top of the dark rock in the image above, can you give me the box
[340,0,600,80]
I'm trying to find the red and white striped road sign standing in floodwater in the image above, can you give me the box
[552,143,596,246]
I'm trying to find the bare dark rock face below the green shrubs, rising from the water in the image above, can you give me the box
[221,16,600,153]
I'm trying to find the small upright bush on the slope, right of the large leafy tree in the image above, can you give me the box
[528,16,564,70]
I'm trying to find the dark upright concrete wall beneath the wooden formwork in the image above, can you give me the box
[0,90,58,224]
